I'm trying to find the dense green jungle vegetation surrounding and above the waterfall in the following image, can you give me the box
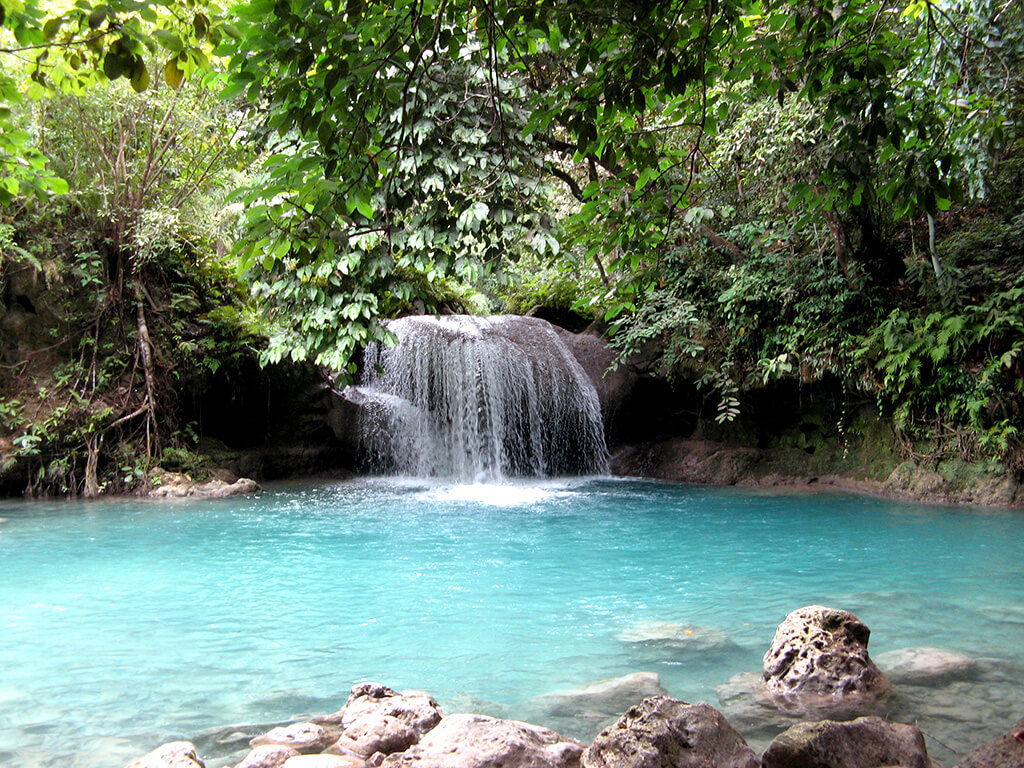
[0,0,1024,496]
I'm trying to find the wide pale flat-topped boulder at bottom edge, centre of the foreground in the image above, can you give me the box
[383,715,583,768]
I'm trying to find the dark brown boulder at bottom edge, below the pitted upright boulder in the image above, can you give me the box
[761,717,931,768]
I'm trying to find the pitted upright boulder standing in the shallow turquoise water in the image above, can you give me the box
[762,605,892,700]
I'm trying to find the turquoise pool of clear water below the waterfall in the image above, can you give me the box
[0,480,1024,768]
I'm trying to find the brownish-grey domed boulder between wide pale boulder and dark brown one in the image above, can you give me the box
[583,696,759,768]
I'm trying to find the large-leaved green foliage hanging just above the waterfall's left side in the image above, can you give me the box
[228,8,558,371]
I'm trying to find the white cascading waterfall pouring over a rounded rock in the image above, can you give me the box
[345,315,608,482]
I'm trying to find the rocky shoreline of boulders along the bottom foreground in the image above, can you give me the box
[121,605,1024,768]
